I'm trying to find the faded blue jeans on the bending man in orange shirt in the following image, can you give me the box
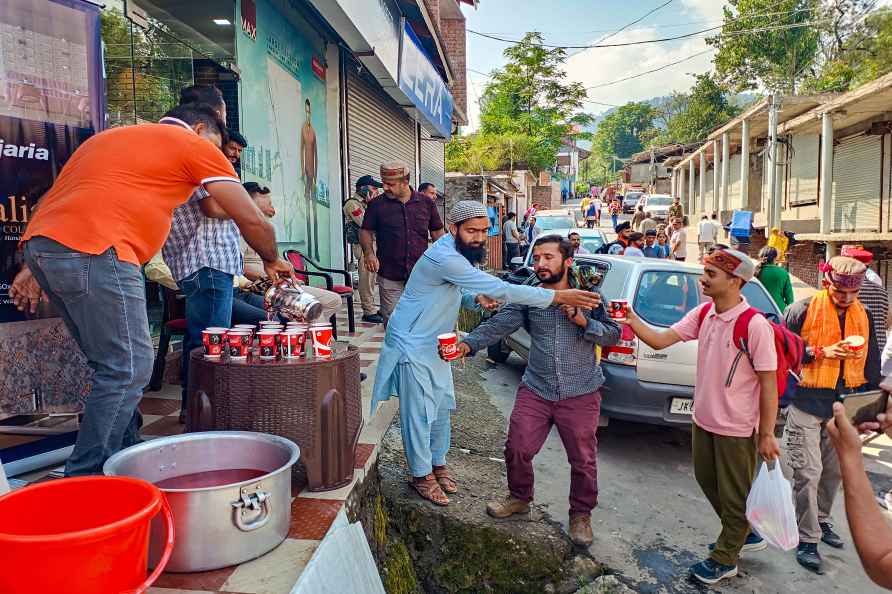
[25,237,155,476]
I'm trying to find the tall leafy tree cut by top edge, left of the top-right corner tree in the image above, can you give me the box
[706,0,822,93]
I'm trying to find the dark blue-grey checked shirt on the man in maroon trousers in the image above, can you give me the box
[463,304,620,401]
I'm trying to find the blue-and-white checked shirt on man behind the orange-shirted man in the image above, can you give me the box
[162,188,244,282]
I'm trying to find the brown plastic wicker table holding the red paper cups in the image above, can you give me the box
[186,343,362,491]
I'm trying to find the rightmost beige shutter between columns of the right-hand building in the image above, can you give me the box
[832,136,883,232]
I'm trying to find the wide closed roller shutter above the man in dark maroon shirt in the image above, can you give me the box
[347,69,416,188]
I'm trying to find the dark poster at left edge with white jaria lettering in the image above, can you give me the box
[0,0,103,322]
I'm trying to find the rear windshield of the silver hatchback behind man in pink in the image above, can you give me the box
[636,270,779,326]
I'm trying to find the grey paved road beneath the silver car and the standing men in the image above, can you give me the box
[474,355,892,594]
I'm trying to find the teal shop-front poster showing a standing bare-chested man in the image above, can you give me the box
[236,0,331,264]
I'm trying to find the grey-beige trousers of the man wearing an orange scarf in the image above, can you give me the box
[781,405,842,543]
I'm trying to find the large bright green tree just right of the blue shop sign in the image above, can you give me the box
[480,32,592,172]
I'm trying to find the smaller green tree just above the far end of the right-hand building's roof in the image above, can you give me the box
[657,74,740,144]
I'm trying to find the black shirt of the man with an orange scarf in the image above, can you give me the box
[784,297,882,419]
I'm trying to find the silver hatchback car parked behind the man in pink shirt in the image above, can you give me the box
[489,255,781,426]
